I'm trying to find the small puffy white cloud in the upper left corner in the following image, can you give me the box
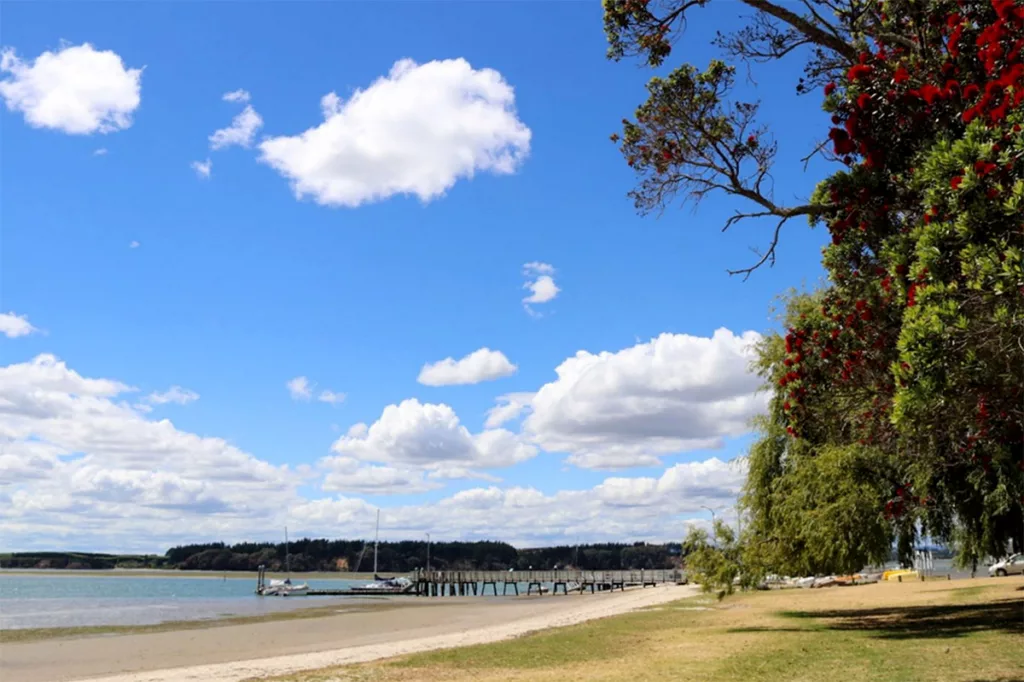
[0,43,142,135]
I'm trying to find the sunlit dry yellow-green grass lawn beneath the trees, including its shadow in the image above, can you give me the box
[262,578,1024,682]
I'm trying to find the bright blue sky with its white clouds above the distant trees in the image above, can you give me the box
[0,2,825,550]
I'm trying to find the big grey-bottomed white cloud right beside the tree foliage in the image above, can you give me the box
[523,329,767,468]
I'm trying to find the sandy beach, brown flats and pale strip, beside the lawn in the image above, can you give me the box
[0,586,697,682]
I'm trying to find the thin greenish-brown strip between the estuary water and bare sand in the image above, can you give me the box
[0,597,409,644]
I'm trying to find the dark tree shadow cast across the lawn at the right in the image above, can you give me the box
[780,599,1024,638]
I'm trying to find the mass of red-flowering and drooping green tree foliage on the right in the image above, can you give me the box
[605,0,1024,572]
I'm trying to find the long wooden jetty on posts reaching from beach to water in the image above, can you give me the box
[411,568,686,597]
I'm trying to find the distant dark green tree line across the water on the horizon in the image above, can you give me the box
[0,539,680,573]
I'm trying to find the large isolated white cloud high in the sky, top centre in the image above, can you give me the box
[259,58,530,207]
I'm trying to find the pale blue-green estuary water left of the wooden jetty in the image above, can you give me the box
[0,570,367,630]
